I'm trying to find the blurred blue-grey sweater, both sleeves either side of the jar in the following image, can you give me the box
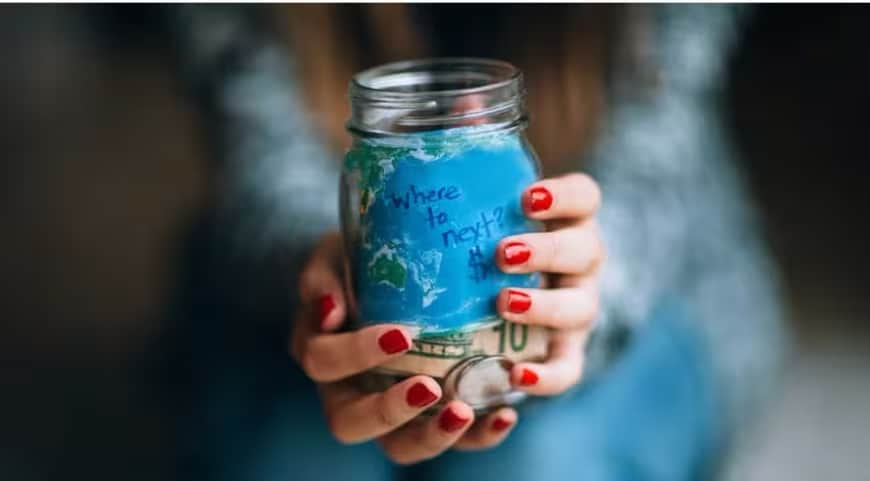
[165,5,785,468]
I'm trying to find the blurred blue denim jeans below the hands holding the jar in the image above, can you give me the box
[191,304,718,481]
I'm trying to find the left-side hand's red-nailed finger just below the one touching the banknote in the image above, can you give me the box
[323,376,442,444]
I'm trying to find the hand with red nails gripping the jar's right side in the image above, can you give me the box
[496,174,605,395]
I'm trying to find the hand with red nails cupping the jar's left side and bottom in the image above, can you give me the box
[290,233,517,464]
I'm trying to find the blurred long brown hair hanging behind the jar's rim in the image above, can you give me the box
[278,4,615,172]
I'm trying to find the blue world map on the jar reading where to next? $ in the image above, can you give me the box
[342,127,540,336]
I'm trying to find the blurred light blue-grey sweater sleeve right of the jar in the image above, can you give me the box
[588,5,785,446]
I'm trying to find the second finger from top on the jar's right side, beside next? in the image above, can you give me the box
[496,220,604,274]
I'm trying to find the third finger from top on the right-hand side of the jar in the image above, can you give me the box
[496,282,598,329]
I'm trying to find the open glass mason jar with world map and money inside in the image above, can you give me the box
[340,58,546,409]
